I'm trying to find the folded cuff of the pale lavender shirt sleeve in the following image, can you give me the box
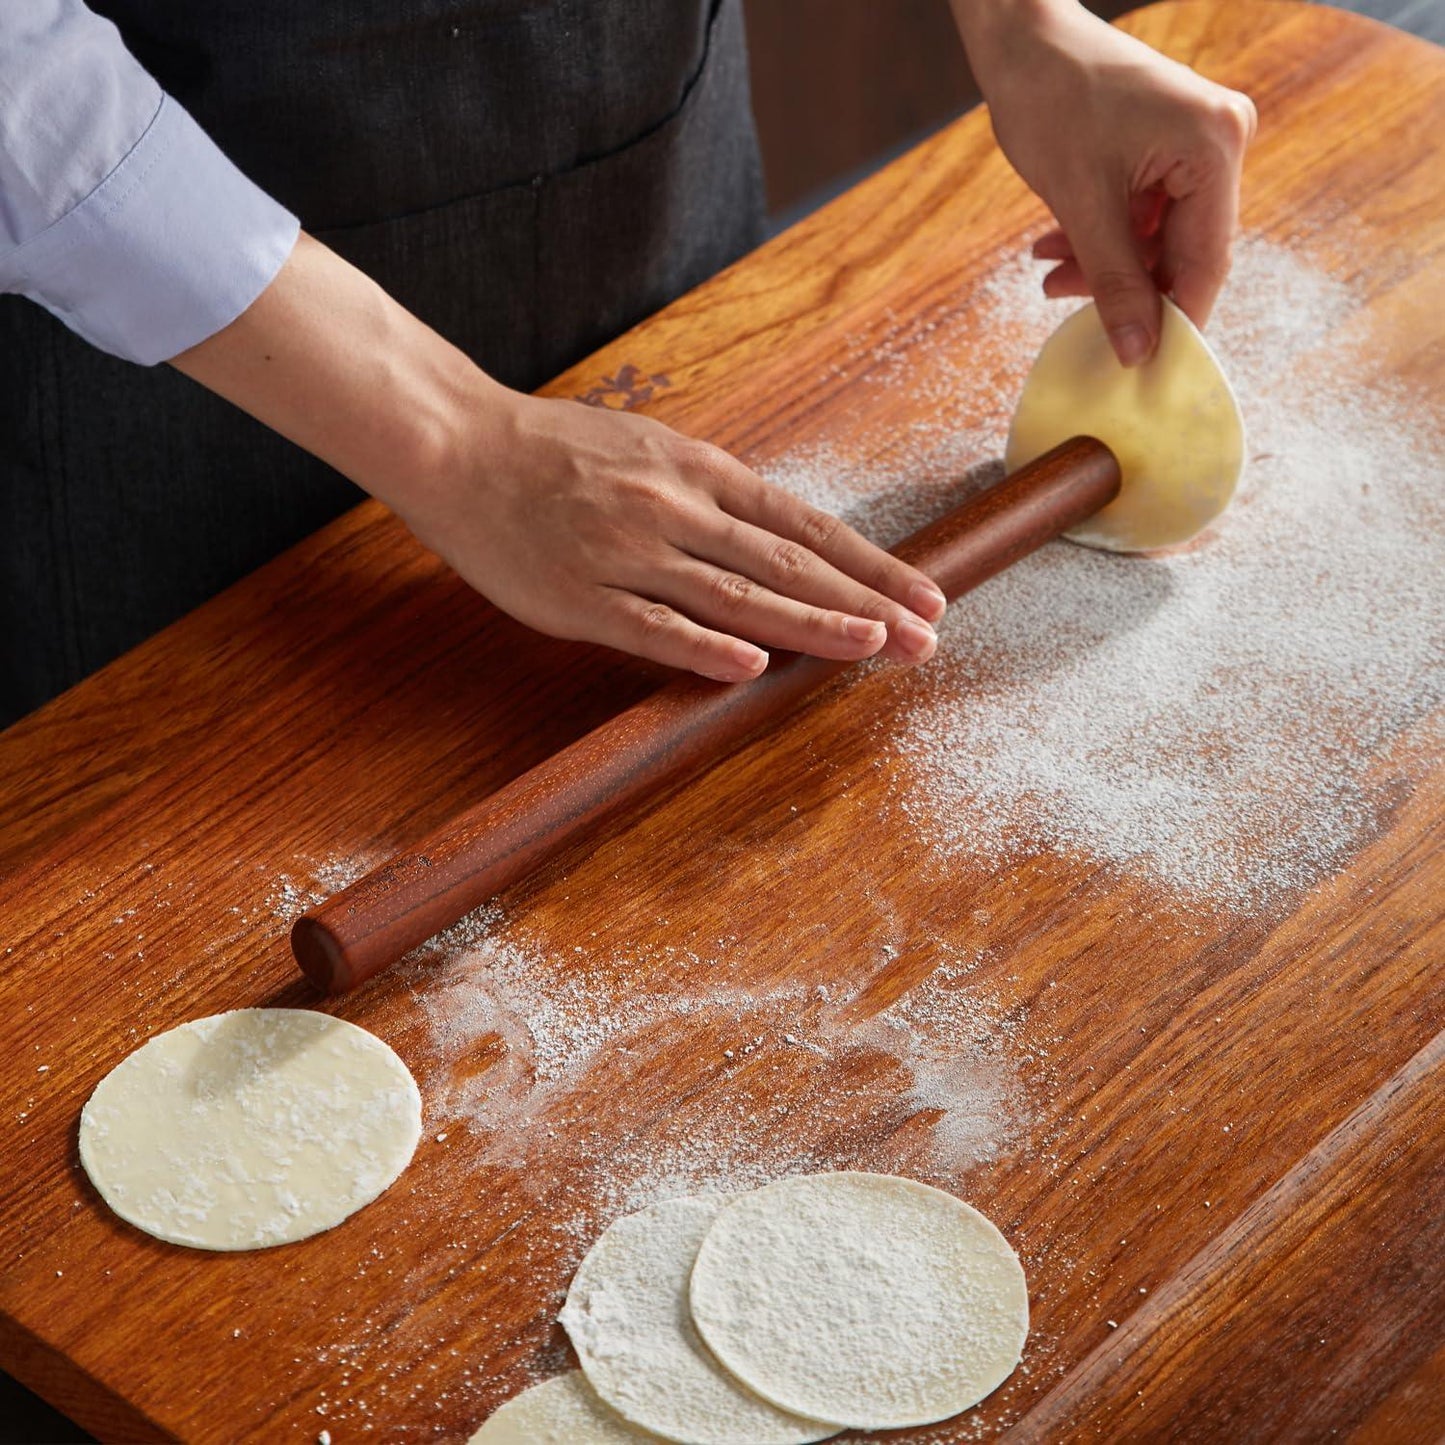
[0,95,299,366]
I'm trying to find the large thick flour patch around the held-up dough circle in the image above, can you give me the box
[764,238,1445,910]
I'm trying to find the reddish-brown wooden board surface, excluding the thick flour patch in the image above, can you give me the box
[0,0,1445,1445]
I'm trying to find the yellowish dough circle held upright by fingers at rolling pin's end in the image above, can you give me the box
[1004,298,1244,552]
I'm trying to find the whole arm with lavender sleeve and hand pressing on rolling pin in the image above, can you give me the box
[0,0,944,681]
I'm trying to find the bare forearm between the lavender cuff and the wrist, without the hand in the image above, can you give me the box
[171,234,491,514]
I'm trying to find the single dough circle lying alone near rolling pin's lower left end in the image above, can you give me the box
[79,1009,422,1250]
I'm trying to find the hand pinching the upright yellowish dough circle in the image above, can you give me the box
[954,0,1257,366]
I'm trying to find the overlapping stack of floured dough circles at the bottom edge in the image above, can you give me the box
[473,1172,1029,1445]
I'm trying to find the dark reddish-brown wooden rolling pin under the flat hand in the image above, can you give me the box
[290,436,1120,993]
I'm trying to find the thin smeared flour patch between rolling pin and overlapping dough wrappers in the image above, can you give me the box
[413,912,1023,1196]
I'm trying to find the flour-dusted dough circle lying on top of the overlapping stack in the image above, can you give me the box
[691,1173,1029,1431]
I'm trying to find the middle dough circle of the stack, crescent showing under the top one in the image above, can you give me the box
[561,1195,838,1445]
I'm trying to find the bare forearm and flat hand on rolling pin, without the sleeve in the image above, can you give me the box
[173,234,944,682]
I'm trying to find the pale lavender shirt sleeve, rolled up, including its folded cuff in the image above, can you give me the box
[0,0,298,366]
